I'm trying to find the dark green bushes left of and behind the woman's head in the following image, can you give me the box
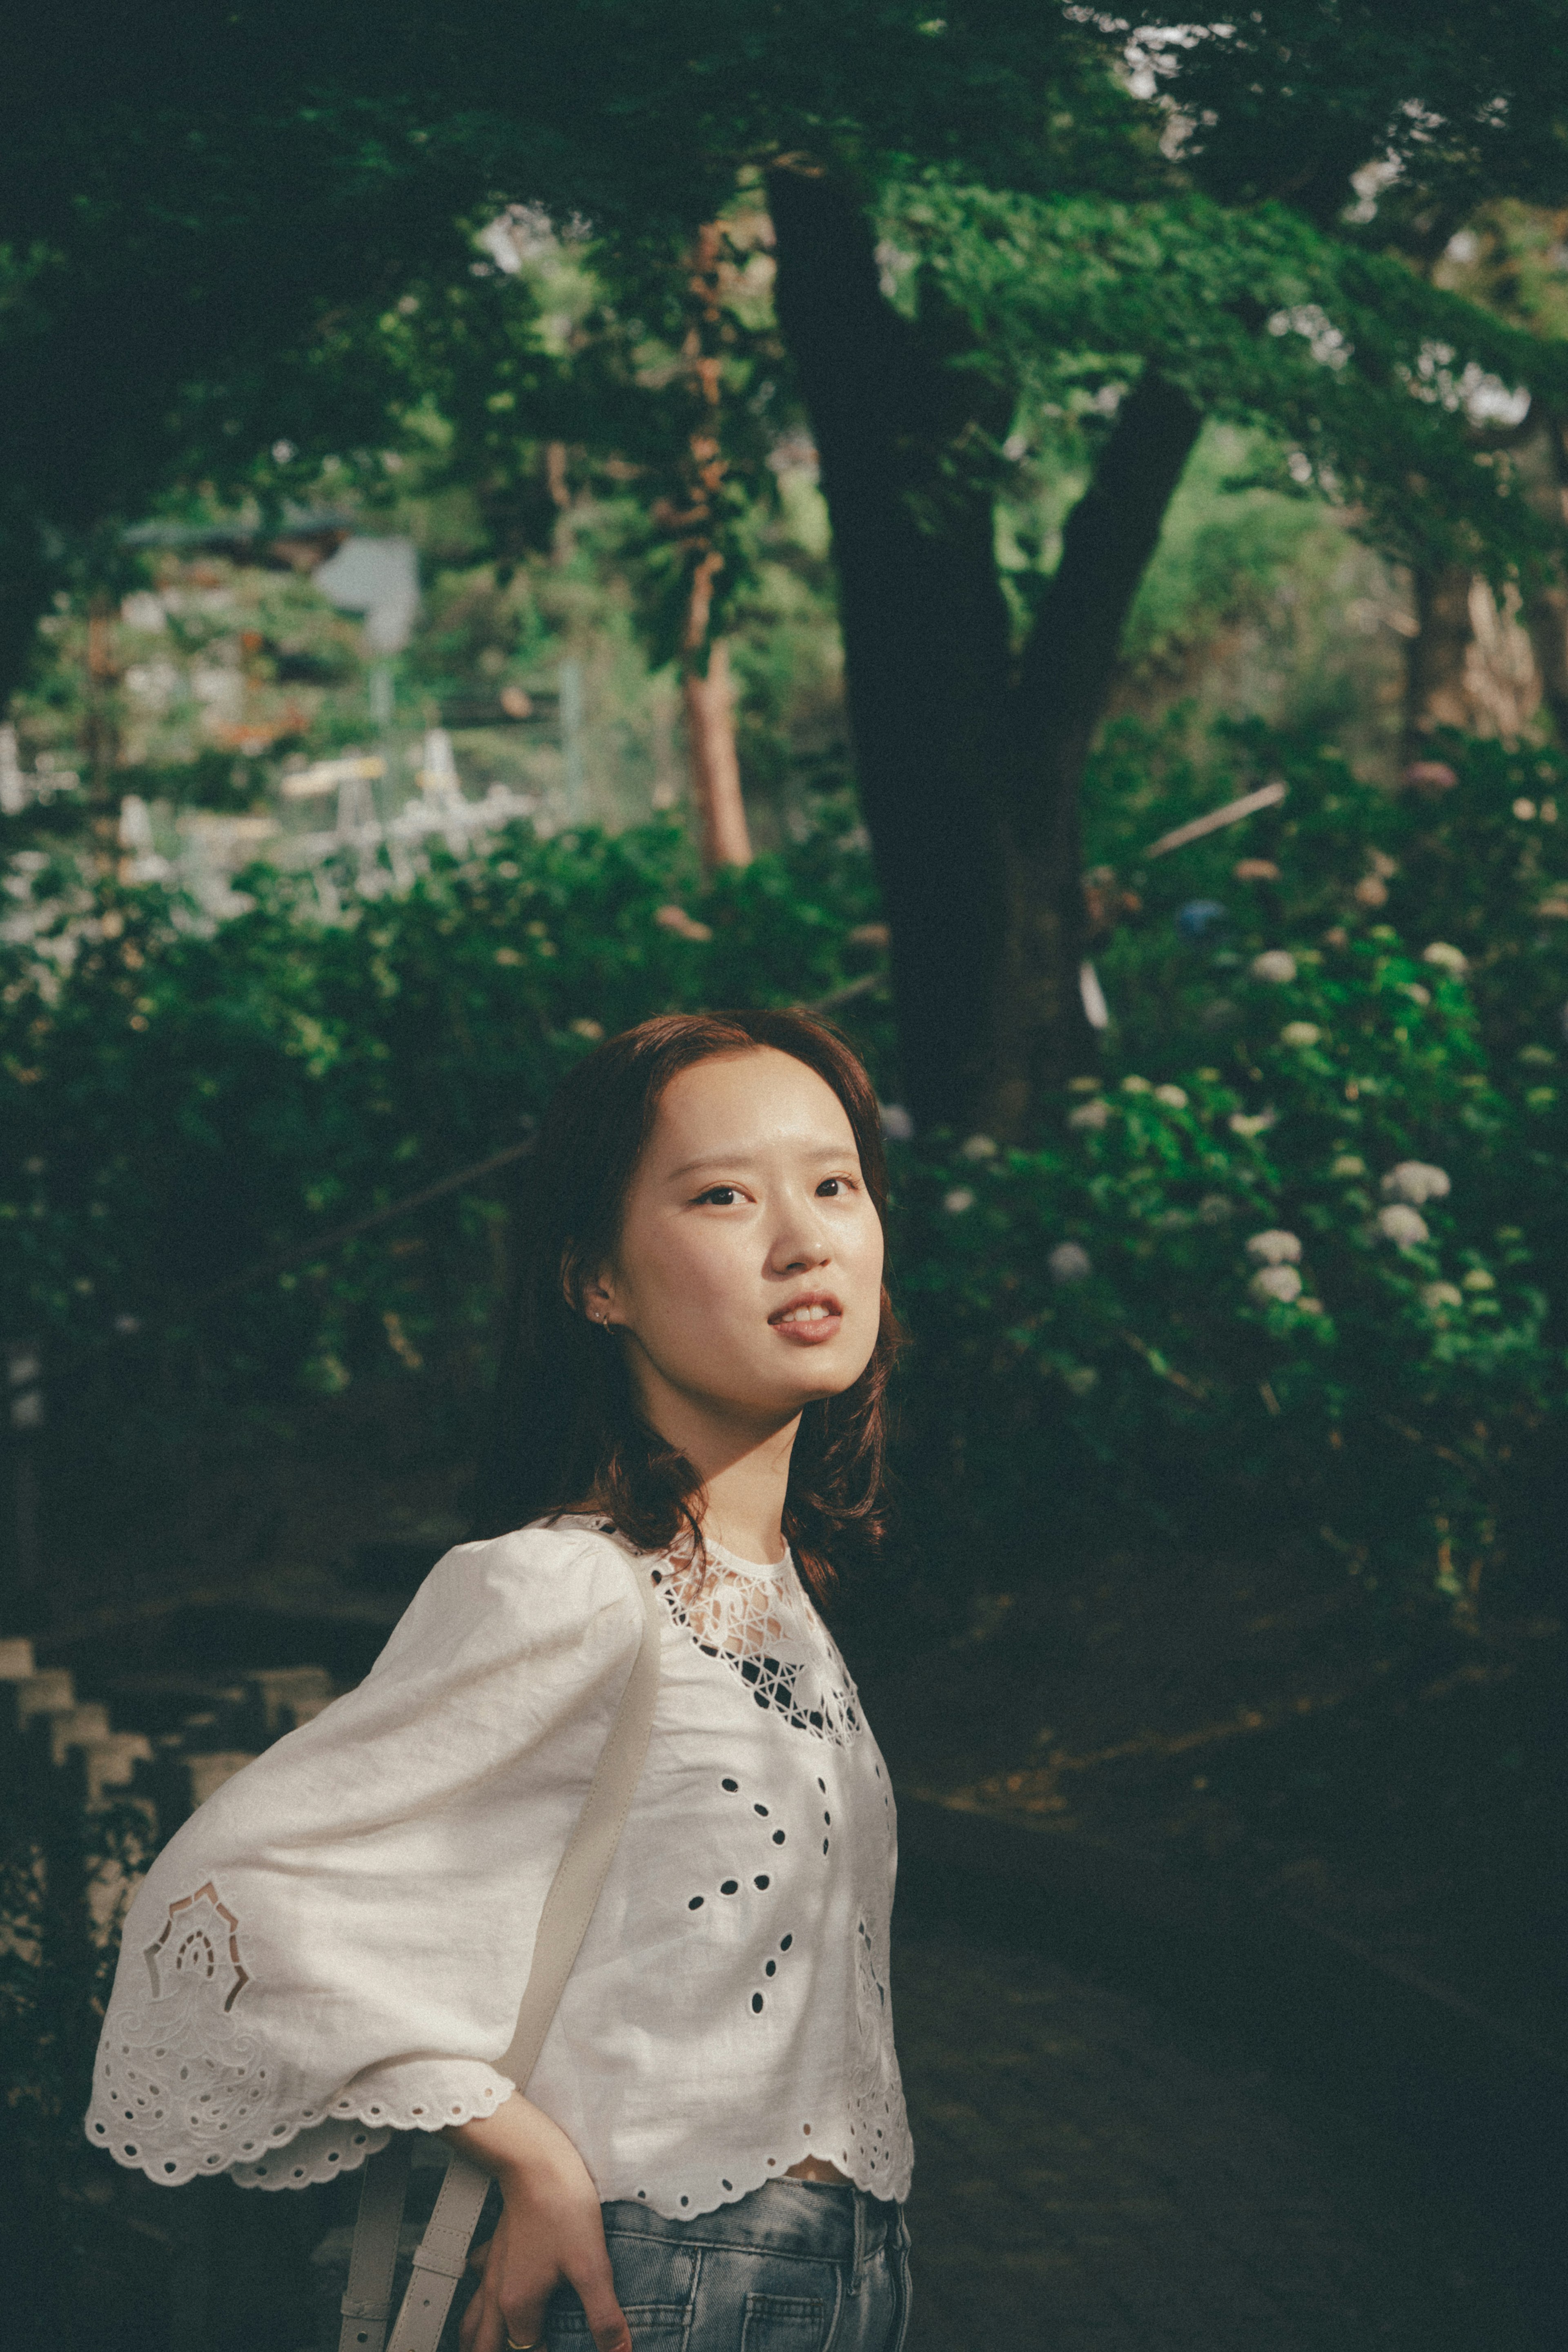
[0,823,872,1388]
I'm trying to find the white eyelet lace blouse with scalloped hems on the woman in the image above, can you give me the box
[87,1515,912,2220]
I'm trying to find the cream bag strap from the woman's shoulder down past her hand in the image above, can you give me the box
[339,1559,665,2352]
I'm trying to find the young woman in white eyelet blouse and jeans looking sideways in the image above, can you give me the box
[87,1011,910,2352]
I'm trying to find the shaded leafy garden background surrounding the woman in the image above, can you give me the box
[0,0,1568,2352]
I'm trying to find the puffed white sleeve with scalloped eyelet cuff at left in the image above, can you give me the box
[87,1527,642,2187]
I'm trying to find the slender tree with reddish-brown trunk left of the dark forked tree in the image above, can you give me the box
[397,198,783,870]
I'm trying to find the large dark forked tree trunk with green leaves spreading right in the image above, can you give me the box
[769,5,1566,1134]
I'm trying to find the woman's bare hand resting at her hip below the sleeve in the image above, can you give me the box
[442,2091,633,2352]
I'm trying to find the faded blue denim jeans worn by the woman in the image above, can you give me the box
[546,2180,910,2352]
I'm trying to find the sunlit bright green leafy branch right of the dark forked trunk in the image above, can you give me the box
[889,174,1568,574]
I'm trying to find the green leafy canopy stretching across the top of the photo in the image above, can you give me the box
[0,0,1566,701]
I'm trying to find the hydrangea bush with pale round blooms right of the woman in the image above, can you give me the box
[900,731,1568,1611]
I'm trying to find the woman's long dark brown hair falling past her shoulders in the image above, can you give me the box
[475,1011,900,1595]
